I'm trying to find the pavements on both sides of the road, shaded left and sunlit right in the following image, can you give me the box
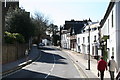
[2,46,116,78]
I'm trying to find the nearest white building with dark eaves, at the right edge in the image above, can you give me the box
[100,1,120,67]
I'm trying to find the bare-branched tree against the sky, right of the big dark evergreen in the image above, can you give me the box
[32,12,49,43]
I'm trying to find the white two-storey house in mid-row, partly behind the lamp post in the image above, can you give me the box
[76,22,99,56]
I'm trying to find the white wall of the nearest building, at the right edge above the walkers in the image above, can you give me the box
[101,2,120,67]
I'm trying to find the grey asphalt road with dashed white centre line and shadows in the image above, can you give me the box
[3,47,80,79]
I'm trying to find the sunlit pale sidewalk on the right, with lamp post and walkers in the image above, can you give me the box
[62,49,110,78]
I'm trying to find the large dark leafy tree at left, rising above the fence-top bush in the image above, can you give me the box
[5,8,34,42]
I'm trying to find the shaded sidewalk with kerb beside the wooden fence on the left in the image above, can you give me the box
[2,45,40,76]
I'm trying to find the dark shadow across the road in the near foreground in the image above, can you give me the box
[2,69,69,80]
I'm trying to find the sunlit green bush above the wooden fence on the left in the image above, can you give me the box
[5,32,25,44]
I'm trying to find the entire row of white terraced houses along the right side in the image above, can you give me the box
[61,0,120,68]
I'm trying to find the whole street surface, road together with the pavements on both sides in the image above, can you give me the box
[3,46,112,80]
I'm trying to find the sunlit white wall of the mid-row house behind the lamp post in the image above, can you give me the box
[77,23,99,56]
